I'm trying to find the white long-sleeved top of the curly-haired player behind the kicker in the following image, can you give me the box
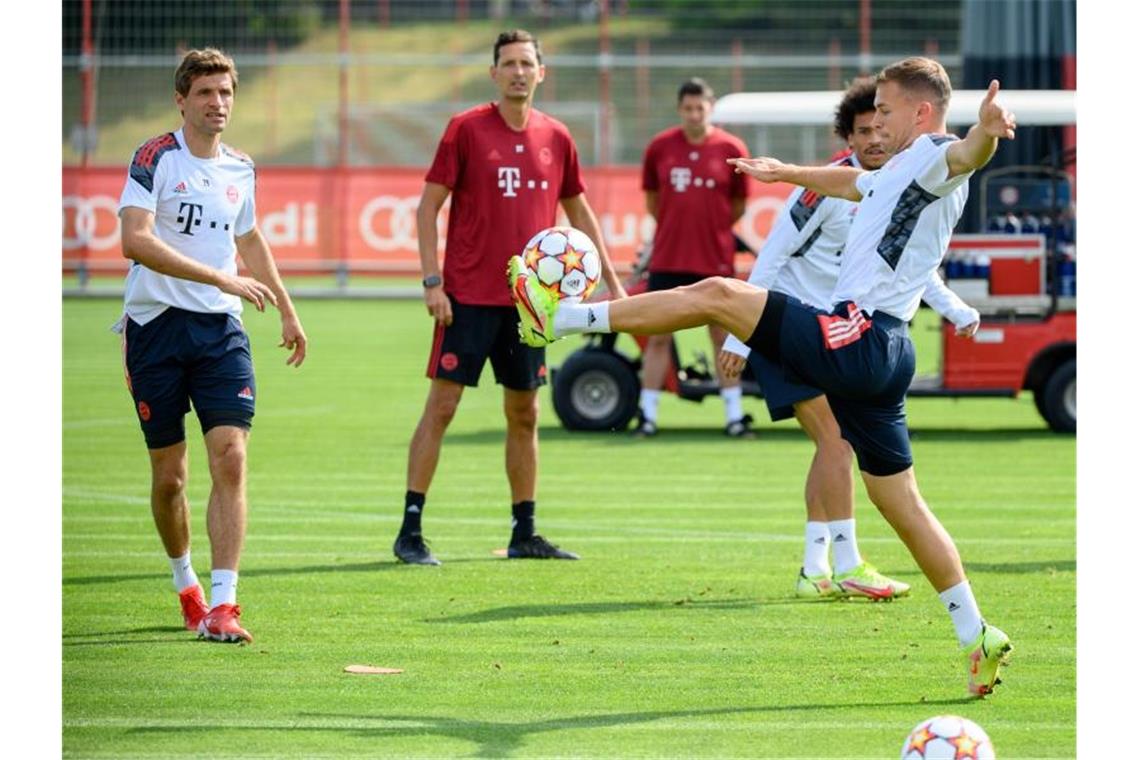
[724,155,979,357]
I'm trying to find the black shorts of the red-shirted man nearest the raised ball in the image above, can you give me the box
[428,296,546,391]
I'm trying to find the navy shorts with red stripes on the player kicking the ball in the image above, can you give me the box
[747,291,914,475]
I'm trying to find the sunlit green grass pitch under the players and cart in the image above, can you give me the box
[62,301,1076,758]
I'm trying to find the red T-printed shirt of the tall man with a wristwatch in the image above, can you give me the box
[424,103,586,307]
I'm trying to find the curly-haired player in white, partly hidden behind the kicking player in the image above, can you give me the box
[718,76,979,600]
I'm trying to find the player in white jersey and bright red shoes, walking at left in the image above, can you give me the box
[116,48,308,641]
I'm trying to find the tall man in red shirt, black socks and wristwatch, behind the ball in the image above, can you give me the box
[392,30,625,565]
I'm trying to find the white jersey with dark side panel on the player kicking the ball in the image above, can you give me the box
[831,134,972,321]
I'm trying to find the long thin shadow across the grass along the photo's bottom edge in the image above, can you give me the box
[129,697,976,758]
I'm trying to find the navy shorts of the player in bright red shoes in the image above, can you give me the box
[123,307,257,449]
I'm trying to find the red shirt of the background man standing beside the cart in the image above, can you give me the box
[642,126,748,276]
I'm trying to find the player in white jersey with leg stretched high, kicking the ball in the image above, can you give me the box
[507,58,1016,696]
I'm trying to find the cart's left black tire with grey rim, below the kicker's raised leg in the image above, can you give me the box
[552,349,641,431]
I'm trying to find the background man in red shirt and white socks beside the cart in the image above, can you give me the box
[634,77,755,438]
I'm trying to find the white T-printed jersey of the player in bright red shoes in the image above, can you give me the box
[119,130,257,325]
